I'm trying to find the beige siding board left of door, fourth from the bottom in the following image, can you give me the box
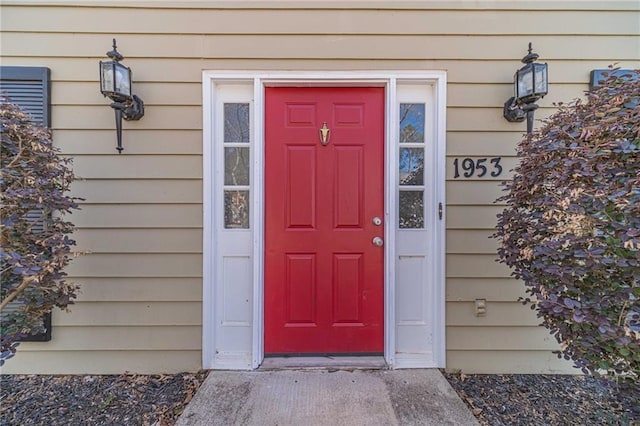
[73,277,202,302]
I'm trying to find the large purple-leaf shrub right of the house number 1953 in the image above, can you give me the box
[495,71,640,383]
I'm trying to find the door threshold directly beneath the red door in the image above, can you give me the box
[258,356,389,370]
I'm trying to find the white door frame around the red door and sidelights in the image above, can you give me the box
[202,71,446,369]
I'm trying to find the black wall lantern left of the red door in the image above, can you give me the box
[100,38,144,154]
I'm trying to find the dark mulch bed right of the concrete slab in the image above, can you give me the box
[445,374,640,426]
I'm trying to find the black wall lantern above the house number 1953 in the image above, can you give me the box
[503,43,549,133]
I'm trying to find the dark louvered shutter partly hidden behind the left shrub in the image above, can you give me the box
[0,67,51,342]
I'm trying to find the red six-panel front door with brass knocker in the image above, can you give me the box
[265,87,384,354]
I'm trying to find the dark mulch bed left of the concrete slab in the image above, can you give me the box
[0,372,207,426]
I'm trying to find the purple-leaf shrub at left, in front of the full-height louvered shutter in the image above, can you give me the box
[0,99,78,365]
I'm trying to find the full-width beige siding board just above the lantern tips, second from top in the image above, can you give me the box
[3,7,638,35]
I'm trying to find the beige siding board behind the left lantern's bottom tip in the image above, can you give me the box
[53,131,202,158]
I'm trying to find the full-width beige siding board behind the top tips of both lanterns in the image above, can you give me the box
[2,32,640,60]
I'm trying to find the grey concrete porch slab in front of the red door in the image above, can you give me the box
[176,369,478,426]
